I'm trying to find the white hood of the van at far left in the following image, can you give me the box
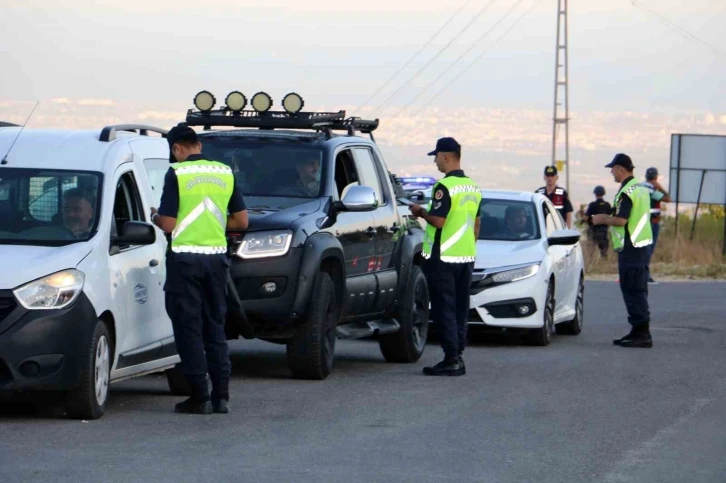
[0,242,92,289]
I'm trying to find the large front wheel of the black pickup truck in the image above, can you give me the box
[287,272,340,380]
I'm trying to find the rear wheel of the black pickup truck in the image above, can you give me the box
[379,265,429,363]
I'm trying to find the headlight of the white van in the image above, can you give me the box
[13,268,85,310]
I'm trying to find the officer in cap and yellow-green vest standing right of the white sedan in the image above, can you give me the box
[592,153,653,347]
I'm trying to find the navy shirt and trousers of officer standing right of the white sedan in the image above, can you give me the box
[613,177,650,328]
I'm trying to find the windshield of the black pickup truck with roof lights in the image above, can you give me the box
[202,136,325,201]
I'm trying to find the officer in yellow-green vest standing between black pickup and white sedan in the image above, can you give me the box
[409,137,481,376]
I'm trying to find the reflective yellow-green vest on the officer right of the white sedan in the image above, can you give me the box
[610,178,653,252]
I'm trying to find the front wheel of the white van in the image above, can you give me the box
[65,320,112,419]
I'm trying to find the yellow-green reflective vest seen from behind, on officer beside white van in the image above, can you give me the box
[171,160,234,255]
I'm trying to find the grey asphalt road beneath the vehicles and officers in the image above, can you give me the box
[0,282,726,483]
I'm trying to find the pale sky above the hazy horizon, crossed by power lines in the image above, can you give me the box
[0,0,726,112]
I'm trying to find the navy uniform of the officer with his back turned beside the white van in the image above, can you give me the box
[159,155,245,402]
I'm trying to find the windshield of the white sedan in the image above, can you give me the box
[479,198,540,241]
